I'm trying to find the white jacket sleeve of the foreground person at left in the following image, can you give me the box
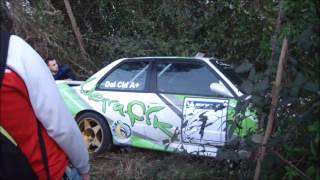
[7,36,89,174]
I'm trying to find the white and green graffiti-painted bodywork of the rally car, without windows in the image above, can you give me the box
[58,57,256,156]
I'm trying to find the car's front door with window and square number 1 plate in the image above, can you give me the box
[154,59,233,145]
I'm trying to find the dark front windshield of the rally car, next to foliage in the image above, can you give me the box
[210,59,242,87]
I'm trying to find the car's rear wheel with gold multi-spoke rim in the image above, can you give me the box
[76,112,112,155]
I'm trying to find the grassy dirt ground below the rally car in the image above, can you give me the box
[90,148,252,180]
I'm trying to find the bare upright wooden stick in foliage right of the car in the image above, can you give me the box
[254,39,288,180]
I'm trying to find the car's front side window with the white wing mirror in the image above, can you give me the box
[156,62,232,97]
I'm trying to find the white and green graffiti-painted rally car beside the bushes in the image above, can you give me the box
[57,57,257,156]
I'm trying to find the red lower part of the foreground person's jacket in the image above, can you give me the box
[0,70,68,180]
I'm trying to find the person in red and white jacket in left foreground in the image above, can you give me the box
[0,35,90,180]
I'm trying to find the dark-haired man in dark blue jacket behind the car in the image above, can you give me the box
[46,58,76,80]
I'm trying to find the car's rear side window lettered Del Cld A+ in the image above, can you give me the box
[98,61,150,91]
